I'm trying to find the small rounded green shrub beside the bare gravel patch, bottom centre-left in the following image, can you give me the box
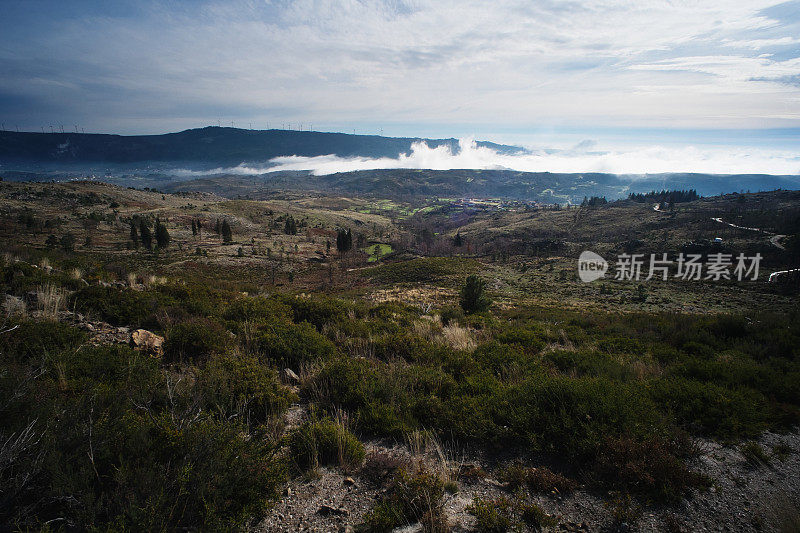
[289,418,364,471]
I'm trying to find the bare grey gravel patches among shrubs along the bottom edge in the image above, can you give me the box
[253,430,800,533]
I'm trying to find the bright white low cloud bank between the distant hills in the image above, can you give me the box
[172,139,800,176]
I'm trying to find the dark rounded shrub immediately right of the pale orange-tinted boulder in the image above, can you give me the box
[164,319,232,362]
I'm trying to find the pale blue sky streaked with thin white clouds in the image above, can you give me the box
[0,0,800,162]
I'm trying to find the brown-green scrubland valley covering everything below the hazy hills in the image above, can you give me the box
[0,182,800,532]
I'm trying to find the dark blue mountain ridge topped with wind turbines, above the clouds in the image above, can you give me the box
[0,126,522,164]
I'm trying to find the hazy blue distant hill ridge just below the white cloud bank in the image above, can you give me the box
[161,169,800,204]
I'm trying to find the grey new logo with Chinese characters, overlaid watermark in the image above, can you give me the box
[578,250,761,283]
